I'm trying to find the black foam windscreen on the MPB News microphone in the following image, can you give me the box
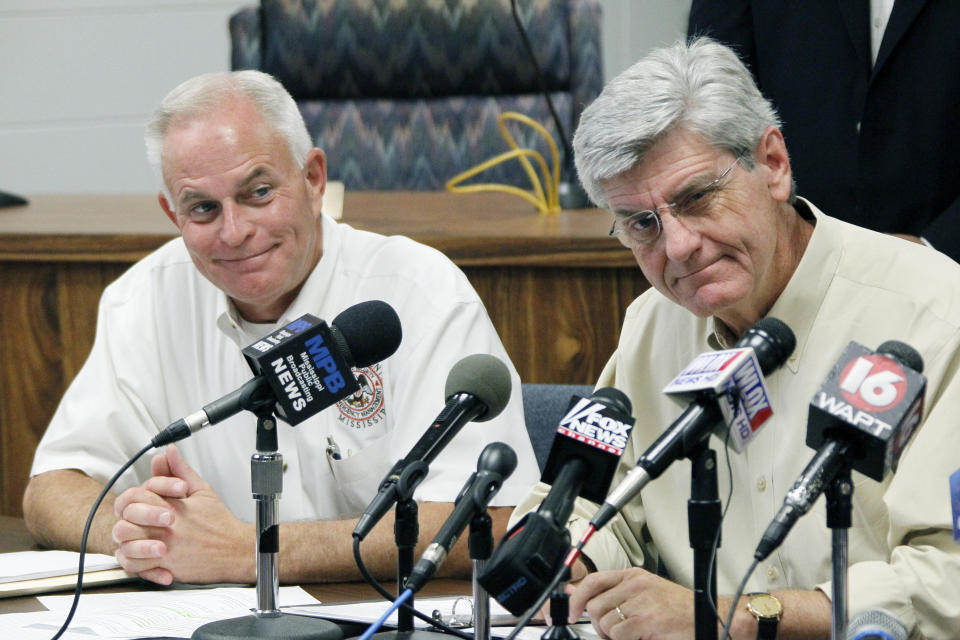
[330,300,403,367]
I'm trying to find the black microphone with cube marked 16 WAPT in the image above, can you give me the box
[753,340,927,561]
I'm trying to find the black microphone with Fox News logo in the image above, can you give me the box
[477,387,634,615]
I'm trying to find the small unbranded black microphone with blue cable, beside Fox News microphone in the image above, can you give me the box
[404,442,517,592]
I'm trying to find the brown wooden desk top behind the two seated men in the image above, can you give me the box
[0,191,636,267]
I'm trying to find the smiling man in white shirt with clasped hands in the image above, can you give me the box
[24,71,536,584]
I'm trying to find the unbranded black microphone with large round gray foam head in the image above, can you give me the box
[353,353,511,540]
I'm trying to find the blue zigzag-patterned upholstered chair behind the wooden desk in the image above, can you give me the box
[230,0,603,190]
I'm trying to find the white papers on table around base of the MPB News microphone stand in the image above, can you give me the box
[0,587,319,640]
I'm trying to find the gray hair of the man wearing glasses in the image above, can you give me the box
[573,38,780,207]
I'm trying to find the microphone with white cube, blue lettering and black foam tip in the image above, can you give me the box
[590,317,796,529]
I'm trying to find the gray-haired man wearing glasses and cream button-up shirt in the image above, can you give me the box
[515,39,960,640]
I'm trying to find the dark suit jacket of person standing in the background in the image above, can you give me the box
[689,0,960,260]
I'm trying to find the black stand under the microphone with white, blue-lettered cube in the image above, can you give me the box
[687,439,722,640]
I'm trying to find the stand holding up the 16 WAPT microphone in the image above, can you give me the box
[824,460,853,640]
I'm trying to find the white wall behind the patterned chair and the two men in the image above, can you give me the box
[0,0,689,195]
